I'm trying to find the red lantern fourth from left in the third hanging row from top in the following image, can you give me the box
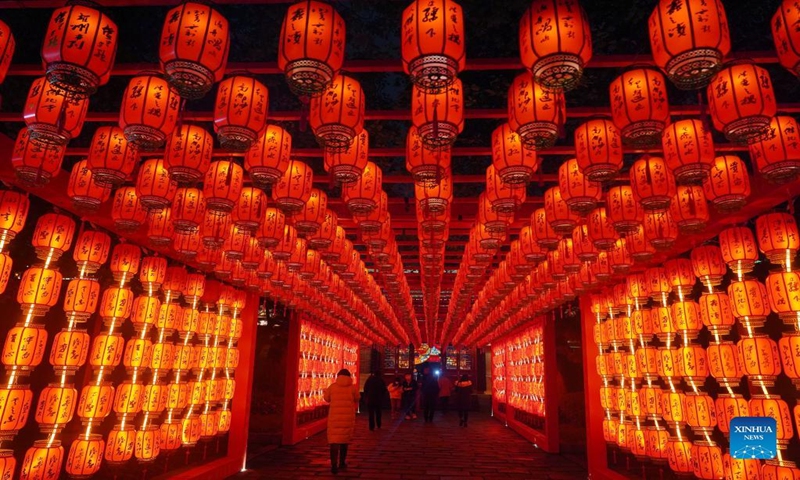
[244,125,292,188]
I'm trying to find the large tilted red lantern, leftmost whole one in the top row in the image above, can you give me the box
[42,3,118,97]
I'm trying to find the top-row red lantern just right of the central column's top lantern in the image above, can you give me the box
[519,0,592,90]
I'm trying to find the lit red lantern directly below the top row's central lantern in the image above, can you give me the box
[411,78,464,150]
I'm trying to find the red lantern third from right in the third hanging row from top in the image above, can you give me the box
[575,119,622,182]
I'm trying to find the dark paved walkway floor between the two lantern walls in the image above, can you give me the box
[233,412,586,480]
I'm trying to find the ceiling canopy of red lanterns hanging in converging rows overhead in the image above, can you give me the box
[0,0,800,344]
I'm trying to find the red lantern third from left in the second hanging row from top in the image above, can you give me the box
[214,75,269,152]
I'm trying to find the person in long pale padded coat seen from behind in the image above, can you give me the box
[322,368,359,475]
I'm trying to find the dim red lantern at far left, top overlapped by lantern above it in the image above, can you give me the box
[11,128,66,187]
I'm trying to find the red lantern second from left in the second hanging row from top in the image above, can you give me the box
[119,75,181,150]
